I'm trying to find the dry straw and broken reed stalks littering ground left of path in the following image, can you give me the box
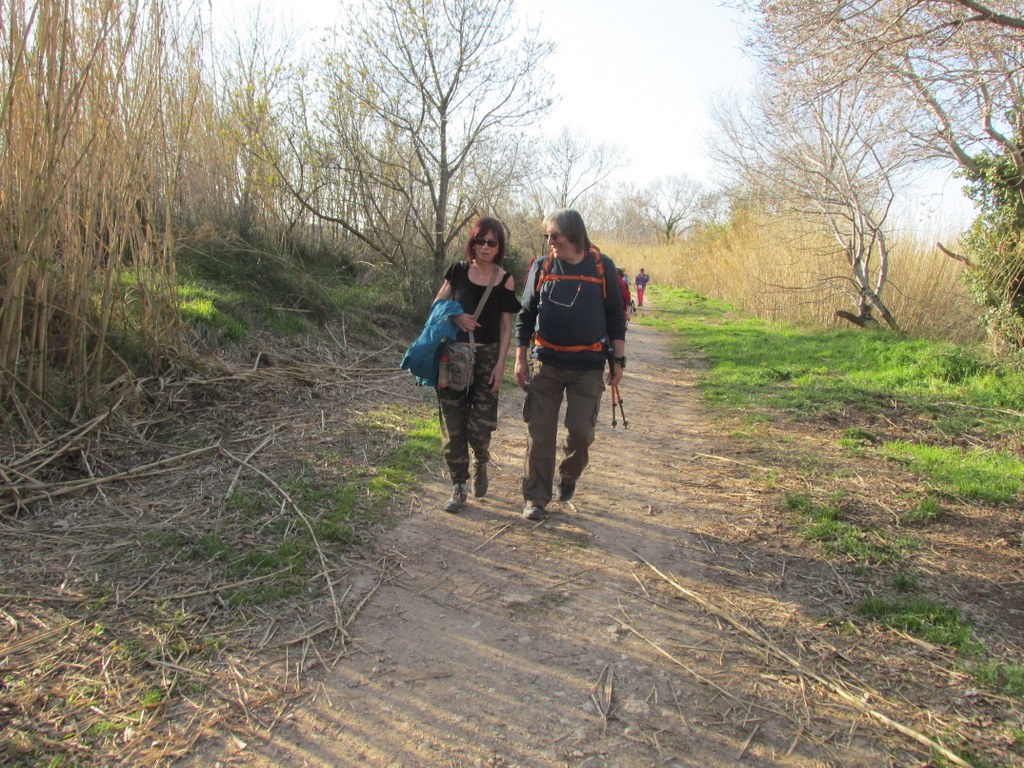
[0,331,410,766]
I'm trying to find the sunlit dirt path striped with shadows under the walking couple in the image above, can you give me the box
[201,313,929,768]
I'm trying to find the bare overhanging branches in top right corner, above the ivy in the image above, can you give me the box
[745,0,1024,201]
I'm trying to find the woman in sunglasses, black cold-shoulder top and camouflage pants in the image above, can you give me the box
[434,217,520,512]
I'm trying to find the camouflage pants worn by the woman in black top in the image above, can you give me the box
[437,344,498,483]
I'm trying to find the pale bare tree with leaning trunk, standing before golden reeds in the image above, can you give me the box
[717,73,914,330]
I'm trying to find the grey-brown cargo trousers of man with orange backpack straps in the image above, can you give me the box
[522,362,604,506]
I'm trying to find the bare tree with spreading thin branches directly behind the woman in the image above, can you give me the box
[276,0,551,287]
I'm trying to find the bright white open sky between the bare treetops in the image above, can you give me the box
[209,0,971,230]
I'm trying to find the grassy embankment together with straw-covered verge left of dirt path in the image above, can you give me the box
[0,244,440,768]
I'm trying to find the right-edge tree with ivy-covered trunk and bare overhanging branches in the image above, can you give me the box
[746,0,1024,346]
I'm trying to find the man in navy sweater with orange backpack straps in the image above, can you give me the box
[515,209,626,520]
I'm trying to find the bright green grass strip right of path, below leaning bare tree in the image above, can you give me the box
[636,288,1024,501]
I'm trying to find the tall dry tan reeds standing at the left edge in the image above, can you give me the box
[0,0,209,426]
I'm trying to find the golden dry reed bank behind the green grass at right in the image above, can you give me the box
[606,210,983,341]
